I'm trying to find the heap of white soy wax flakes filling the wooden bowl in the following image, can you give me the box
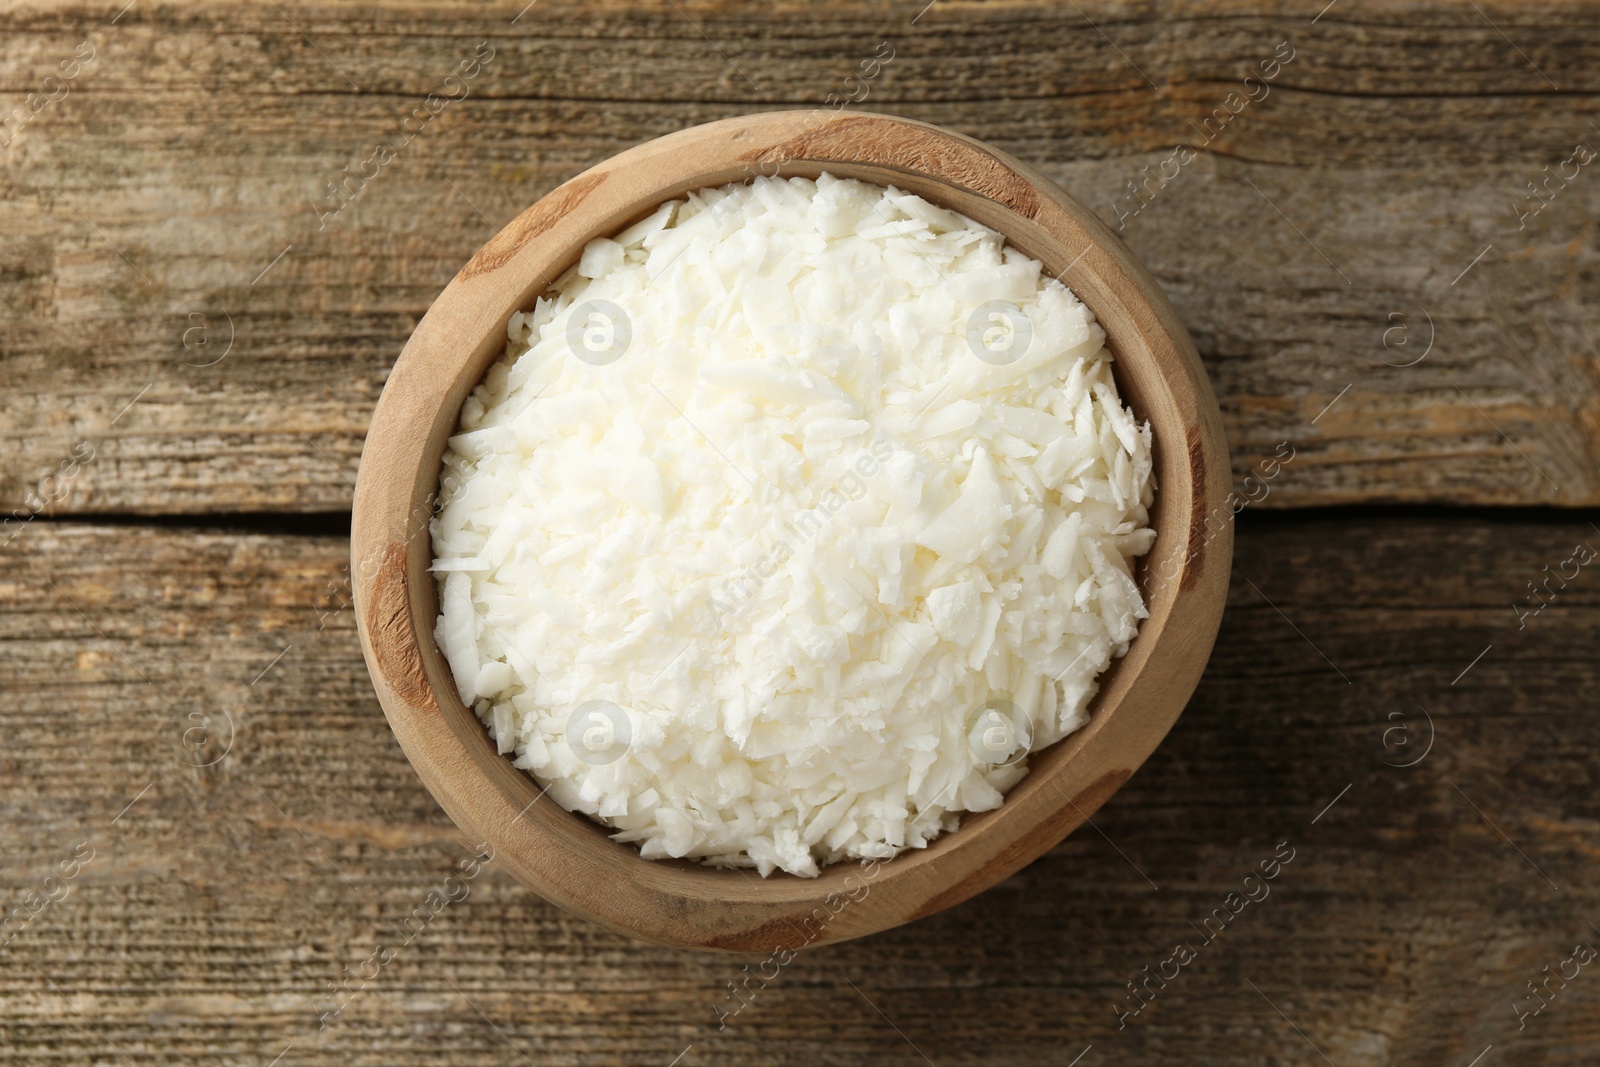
[432,174,1155,877]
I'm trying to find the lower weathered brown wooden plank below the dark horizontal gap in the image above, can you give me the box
[0,510,1600,1067]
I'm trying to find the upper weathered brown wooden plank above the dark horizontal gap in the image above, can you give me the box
[0,0,1600,514]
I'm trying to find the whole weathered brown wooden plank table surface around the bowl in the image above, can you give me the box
[0,0,1600,1067]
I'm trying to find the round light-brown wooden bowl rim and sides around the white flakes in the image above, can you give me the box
[352,112,1232,952]
